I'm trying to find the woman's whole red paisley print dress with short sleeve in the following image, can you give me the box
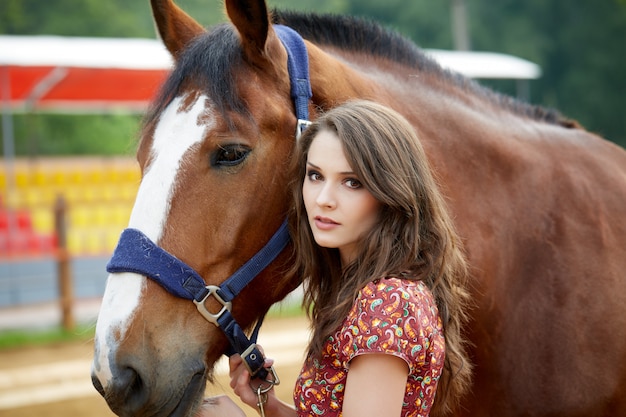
[294,278,445,417]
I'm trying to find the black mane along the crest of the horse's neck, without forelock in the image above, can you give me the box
[272,10,578,128]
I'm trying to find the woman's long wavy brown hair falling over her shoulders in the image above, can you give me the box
[290,100,471,413]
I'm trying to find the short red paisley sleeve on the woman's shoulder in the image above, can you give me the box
[338,279,441,374]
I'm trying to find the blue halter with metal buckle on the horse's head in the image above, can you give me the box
[107,25,313,381]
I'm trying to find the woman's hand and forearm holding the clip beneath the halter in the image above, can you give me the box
[228,355,296,417]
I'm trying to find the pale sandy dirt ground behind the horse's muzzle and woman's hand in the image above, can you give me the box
[0,317,307,417]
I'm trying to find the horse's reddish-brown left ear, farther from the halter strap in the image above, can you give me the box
[150,0,204,59]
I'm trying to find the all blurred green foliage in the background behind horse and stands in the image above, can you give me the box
[0,0,626,153]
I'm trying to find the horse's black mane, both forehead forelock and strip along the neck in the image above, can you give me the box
[145,10,577,127]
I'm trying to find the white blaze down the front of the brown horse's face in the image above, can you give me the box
[93,96,211,386]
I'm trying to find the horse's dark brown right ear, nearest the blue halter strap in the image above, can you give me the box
[226,0,270,60]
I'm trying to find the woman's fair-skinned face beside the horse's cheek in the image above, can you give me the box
[302,130,380,265]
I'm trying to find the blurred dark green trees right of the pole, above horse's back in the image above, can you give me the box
[470,0,626,146]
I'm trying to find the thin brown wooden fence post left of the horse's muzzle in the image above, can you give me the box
[54,194,74,331]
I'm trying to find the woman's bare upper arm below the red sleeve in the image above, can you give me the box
[343,353,409,417]
